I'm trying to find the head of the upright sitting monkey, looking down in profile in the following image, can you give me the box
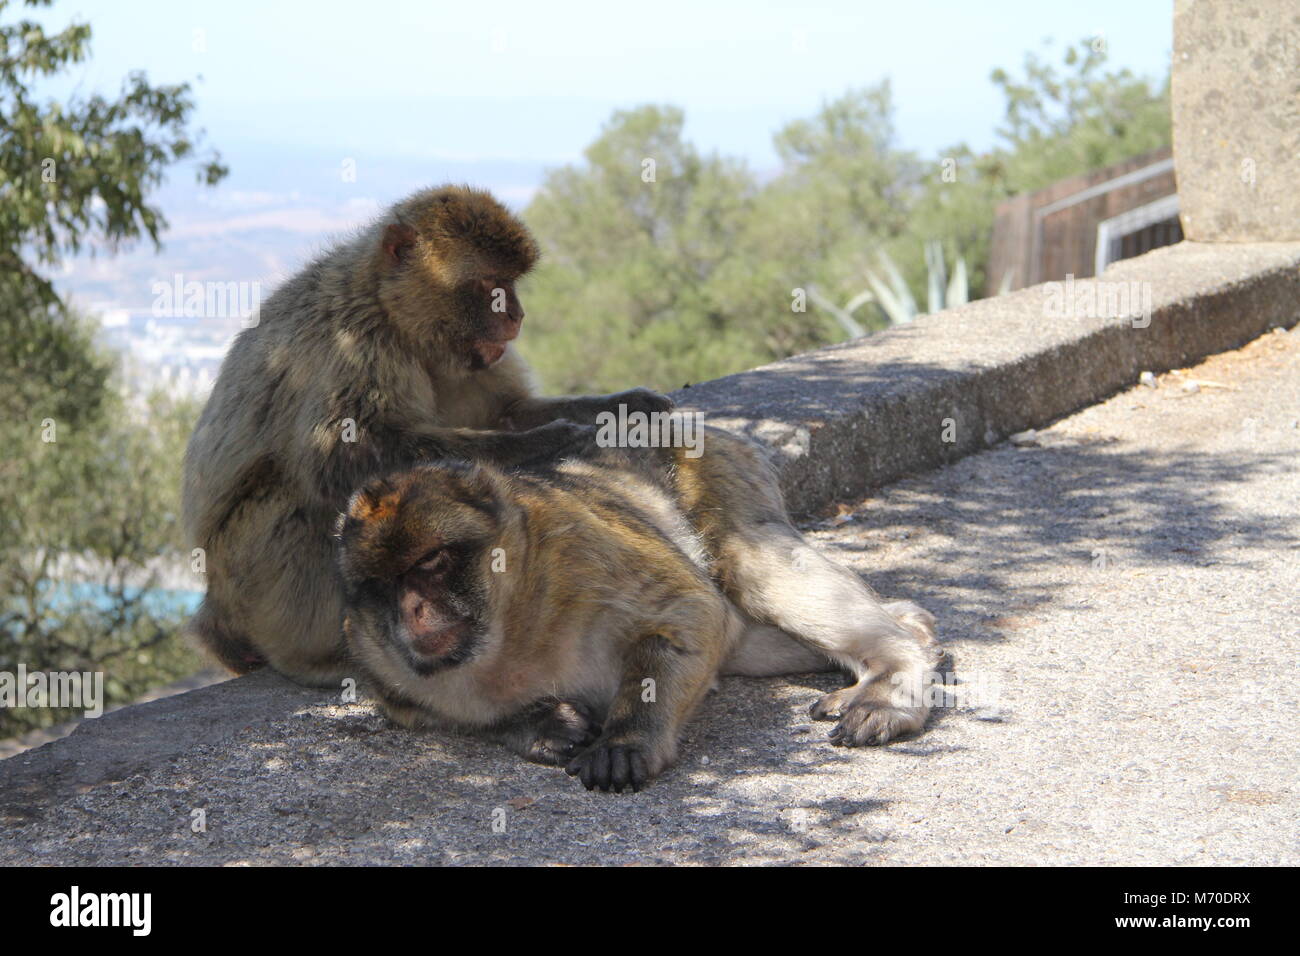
[378,186,538,371]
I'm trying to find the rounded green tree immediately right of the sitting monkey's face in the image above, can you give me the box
[524,107,766,390]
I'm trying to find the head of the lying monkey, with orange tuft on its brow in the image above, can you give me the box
[338,462,510,680]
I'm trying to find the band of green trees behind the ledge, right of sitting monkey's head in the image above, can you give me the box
[521,40,1170,392]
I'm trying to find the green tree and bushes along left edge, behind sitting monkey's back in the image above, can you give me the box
[0,0,225,734]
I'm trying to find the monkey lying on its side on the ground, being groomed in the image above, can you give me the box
[339,429,939,792]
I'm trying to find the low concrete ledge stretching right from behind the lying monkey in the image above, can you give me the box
[675,242,1300,515]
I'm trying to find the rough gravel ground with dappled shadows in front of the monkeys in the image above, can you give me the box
[0,332,1300,864]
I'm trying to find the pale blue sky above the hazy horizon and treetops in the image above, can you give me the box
[35,0,1171,166]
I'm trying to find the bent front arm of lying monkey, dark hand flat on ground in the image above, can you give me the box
[564,598,741,793]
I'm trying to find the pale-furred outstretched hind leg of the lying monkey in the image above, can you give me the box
[718,522,940,747]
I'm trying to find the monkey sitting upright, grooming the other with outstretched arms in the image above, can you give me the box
[182,186,672,685]
